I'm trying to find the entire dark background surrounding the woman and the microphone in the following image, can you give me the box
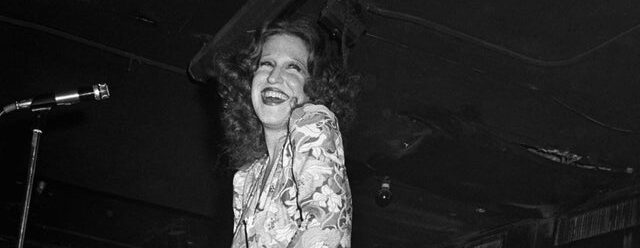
[0,0,640,247]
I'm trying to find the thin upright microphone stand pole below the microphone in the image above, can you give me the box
[18,107,51,248]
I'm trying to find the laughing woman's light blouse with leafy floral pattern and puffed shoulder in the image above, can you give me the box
[231,104,352,248]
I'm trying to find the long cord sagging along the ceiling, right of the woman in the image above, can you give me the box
[366,4,640,67]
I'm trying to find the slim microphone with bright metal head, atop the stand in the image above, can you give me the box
[2,84,110,113]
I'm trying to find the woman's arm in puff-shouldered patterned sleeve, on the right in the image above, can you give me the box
[289,104,352,247]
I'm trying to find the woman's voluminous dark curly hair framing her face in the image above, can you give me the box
[213,19,359,168]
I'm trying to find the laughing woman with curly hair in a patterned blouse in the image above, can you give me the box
[214,19,356,247]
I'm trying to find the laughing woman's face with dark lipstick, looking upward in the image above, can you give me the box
[251,34,309,129]
